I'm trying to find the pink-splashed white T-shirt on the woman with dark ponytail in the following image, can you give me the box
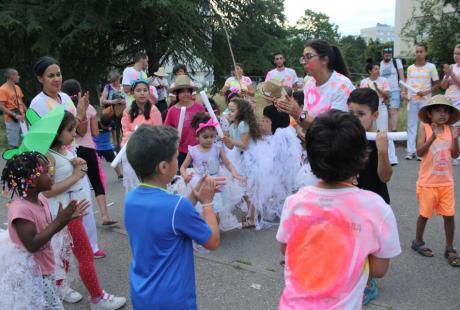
[303,71,355,117]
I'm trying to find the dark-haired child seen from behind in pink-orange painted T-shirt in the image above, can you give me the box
[276,110,401,309]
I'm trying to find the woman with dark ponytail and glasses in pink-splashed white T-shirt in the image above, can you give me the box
[275,40,355,128]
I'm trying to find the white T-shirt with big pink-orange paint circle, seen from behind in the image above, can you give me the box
[276,186,401,309]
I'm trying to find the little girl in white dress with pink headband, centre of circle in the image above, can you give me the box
[180,112,244,230]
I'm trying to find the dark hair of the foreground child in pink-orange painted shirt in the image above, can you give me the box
[305,110,368,183]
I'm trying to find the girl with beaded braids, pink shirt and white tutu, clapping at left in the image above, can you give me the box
[0,152,89,309]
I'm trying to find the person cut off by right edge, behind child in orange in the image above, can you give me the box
[441,44,460,166]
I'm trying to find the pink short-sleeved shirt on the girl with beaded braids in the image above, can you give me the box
[8,195,54,275]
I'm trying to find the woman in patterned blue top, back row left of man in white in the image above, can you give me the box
[99,70,126,151]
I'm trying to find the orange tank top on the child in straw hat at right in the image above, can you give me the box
[417,124,454,187]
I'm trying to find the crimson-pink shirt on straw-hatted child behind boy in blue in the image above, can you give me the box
[165,102,205,153]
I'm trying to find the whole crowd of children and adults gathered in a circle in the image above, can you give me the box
[0,40,460,309]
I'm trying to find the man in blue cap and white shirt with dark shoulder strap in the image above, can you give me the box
[380,47,404,131]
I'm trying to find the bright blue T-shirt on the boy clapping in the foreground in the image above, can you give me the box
[125,187,212,309]
